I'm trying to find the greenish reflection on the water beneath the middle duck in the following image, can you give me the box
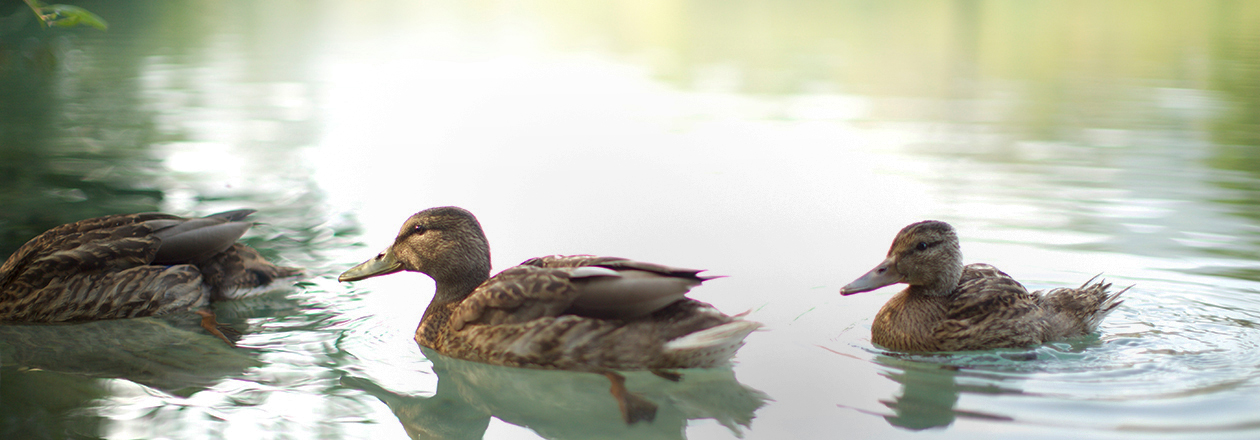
[341,347,769,439]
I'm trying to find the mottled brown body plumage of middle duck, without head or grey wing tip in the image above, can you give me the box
[438,256,736,369]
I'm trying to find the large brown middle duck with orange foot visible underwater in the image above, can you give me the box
[338,207,761,424]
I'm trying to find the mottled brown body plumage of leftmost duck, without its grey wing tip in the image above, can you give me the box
[0,211,300,323]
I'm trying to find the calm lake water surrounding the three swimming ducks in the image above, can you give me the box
[0,0,1260,439]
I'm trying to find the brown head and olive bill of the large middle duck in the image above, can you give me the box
[338,207,490,295]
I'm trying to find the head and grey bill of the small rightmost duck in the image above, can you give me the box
[840,221,963,296]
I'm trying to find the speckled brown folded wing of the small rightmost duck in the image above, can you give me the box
[934,263,1046,352]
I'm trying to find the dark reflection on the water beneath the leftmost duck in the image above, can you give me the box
[0,311,262,439]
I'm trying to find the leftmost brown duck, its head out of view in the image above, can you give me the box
[0,209,302,347]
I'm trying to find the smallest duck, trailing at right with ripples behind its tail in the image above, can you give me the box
[840,221,1129,352]
